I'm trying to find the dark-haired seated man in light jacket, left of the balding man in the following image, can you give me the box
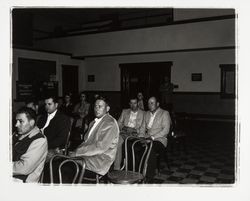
[114,97,144,170]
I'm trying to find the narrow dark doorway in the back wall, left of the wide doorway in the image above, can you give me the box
[62,65,78,99]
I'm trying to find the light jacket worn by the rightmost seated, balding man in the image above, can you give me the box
[139,108,171,147]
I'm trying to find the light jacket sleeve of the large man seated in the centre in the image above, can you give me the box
[76,122,119,156]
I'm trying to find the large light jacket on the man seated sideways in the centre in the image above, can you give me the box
[76,114,119,175]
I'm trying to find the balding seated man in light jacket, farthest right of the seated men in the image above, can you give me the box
[139,96,171,179]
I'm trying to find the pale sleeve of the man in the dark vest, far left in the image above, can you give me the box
[12,138,48,175]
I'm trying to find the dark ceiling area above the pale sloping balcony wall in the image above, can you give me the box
[12,8,173,45]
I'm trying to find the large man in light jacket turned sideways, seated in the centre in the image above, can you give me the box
[70,97,119,176]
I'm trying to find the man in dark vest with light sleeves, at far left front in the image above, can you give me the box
[12,107,48,182]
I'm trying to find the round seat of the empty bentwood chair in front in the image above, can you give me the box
[108,170,144,184]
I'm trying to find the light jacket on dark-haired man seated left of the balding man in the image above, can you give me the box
[118,109,145,133]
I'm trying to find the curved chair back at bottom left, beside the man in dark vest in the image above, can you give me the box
[49,154,85,184]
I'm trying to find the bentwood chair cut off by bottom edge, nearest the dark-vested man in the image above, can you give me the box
[49,154,85,184]
